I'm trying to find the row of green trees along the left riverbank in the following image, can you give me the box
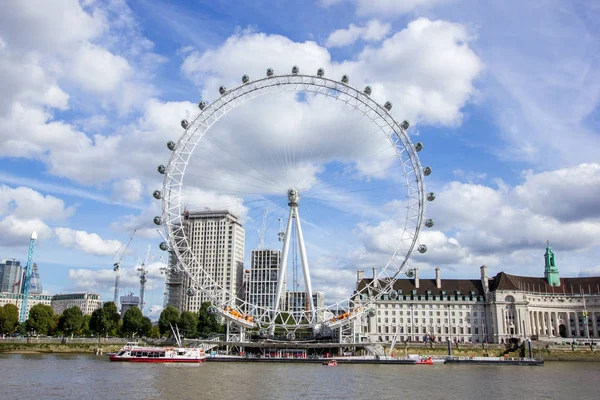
[0,301,224,338]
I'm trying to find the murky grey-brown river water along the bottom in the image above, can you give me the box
[0,354,600,400]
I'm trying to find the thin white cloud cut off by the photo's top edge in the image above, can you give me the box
[321,0,451,18]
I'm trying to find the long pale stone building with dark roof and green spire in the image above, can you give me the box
[354,244,600,343]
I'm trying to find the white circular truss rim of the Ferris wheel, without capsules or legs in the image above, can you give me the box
[162,70,425,328]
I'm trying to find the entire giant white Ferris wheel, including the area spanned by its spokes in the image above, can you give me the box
[154,66,435,333]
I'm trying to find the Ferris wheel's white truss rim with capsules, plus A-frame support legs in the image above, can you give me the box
[154,67,435,340]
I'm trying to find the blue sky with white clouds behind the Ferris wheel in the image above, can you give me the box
[0,0,600,313]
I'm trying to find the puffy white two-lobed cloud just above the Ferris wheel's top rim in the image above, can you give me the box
[182,18,483,125]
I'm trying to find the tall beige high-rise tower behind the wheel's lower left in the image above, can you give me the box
[175,211,245,311]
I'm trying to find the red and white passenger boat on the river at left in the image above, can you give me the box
[110,329,206,363]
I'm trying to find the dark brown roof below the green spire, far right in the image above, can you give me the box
[489,272,600,294]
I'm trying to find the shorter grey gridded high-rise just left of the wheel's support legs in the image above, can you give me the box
[246,249,281,309]
